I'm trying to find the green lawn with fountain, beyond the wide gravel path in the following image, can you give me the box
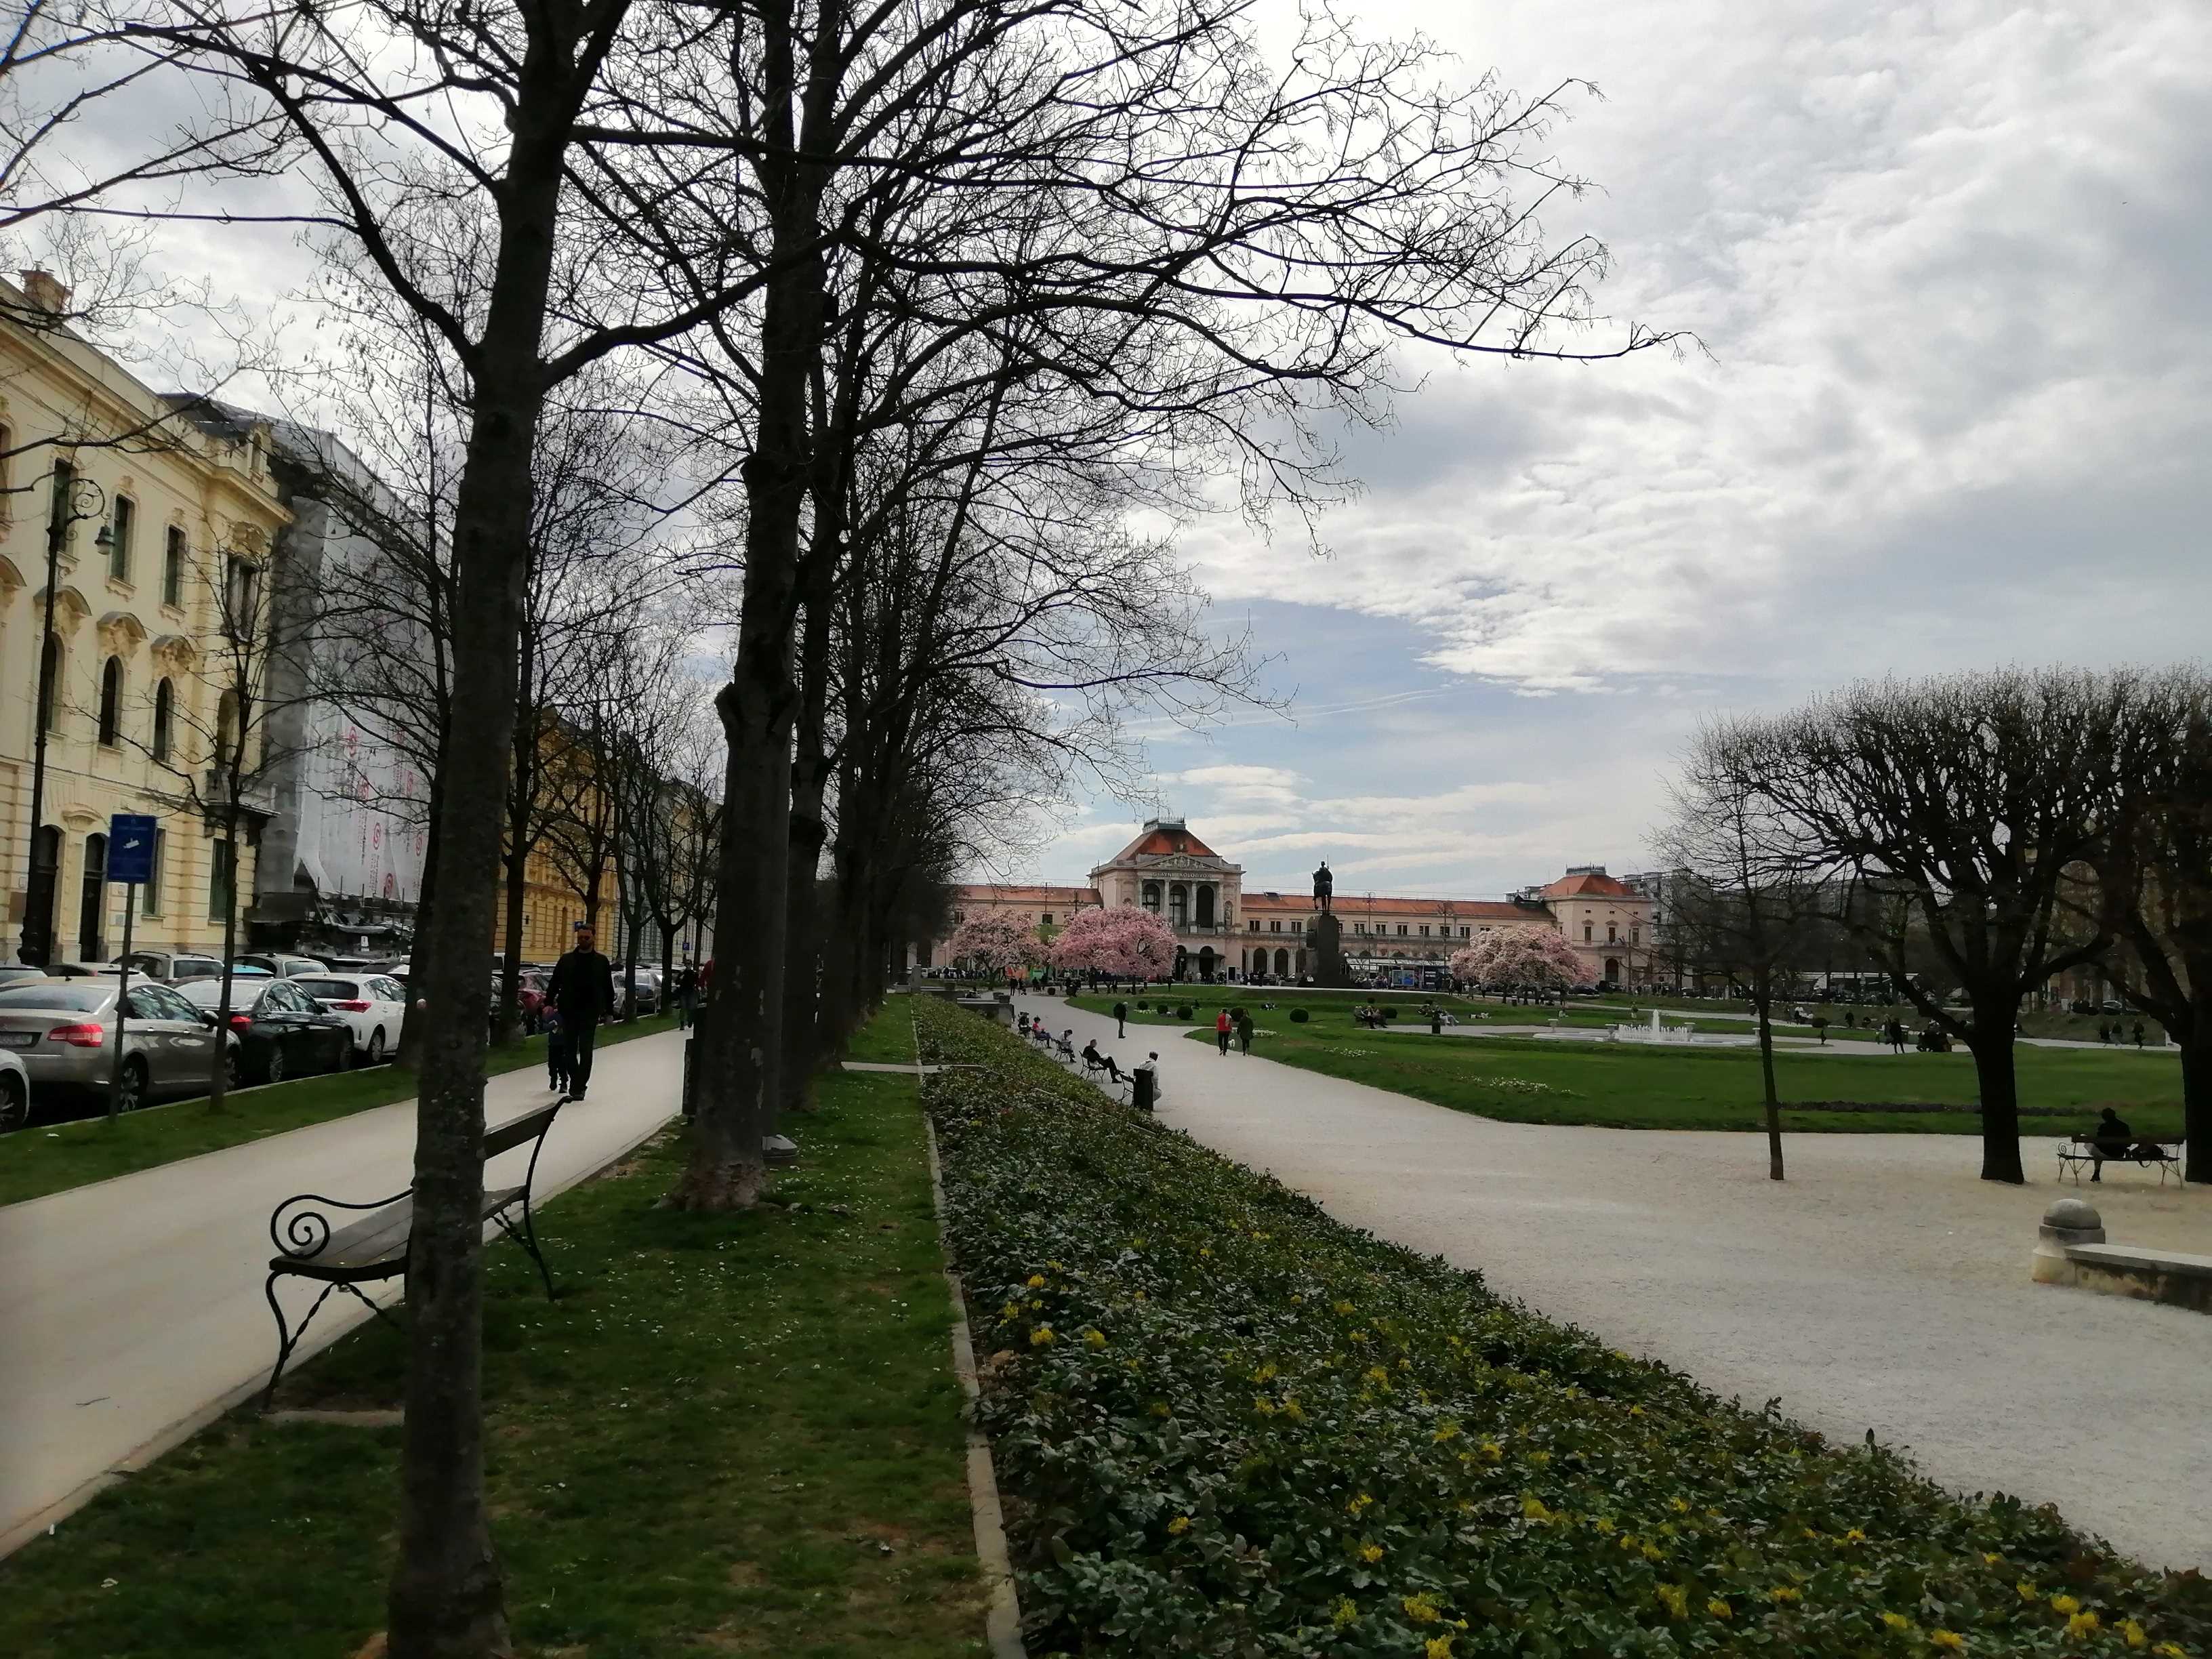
[1150,1006,2181,1137]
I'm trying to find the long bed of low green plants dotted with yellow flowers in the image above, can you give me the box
[916,1000,2212,1659]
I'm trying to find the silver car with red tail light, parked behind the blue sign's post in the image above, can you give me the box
[0,980,230,1111]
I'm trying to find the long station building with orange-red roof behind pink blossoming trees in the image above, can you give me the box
[914,819,1654,984]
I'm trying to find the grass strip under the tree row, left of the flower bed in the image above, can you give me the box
[0,1002,984,1659]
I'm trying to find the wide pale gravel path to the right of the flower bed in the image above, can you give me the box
[1029,1000,2212,1570]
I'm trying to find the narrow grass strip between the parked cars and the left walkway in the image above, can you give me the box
[0,1015,675,1204]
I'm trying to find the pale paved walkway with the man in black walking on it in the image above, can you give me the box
[0,1033,684,1555]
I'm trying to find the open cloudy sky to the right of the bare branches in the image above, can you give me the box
[1022,0,2212,896]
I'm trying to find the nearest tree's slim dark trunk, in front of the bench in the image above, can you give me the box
[387,110,567,1659]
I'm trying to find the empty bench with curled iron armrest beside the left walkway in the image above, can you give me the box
[261,1099,567,1411]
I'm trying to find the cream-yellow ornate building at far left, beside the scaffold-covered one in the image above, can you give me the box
[0,272,287,960]
